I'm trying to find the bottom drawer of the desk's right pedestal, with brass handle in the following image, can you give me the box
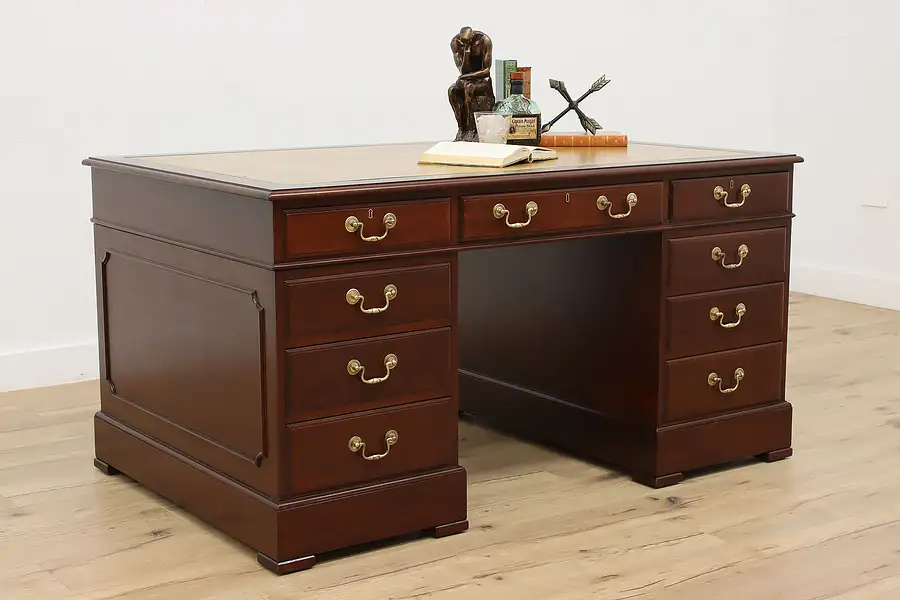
[663,342,784,423]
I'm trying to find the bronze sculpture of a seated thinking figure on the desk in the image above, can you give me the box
[447,27,496,142]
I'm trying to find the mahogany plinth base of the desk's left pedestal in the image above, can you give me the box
[94,412,468,574]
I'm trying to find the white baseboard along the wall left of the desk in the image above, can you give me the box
[0,343,100,392]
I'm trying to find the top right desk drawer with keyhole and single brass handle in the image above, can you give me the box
[672,173,791,222]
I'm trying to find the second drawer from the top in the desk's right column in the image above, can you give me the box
[666,227,787,294]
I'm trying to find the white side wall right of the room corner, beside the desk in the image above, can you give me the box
[774,0,900,309]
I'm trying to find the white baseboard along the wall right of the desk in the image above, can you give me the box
[791,262,900,310]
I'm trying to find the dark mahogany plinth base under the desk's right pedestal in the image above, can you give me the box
[459,371,792,488]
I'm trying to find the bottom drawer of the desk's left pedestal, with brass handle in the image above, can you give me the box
[289,398,458,495]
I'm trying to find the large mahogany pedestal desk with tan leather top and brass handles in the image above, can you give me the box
[85,139,802,573]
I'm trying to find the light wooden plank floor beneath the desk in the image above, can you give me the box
[0,295,900,600]
